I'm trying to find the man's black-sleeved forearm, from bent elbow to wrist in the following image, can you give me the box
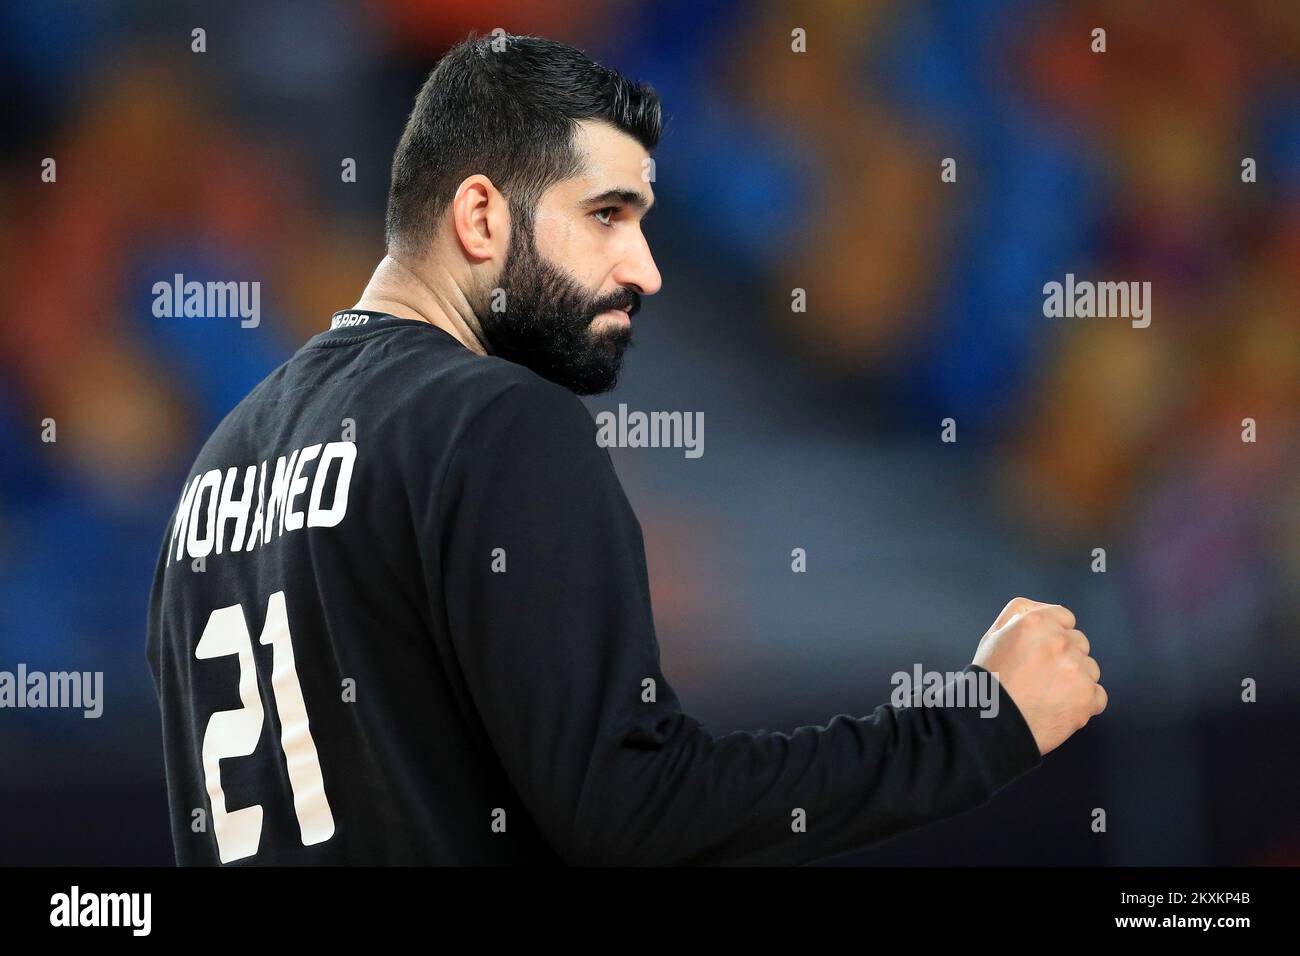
[562,665,1040,865]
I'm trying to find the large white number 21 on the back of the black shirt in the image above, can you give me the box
[194,591,334,864]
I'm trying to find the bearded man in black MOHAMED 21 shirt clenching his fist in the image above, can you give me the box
[148,36,1105,865]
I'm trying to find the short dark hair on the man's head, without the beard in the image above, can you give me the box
[385,34,663,252]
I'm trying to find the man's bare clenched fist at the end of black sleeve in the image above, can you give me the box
[971,597,1106,754]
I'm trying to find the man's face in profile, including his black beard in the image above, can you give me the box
[475,121,662,395]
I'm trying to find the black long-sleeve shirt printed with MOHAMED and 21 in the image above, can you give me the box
[147,312,1041,865]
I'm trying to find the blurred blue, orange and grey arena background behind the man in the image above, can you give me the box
[0,0,1300,865]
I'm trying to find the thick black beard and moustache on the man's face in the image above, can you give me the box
[475,215,641,395]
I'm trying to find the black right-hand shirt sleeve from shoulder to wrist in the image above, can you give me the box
[439,381,1041,865]
